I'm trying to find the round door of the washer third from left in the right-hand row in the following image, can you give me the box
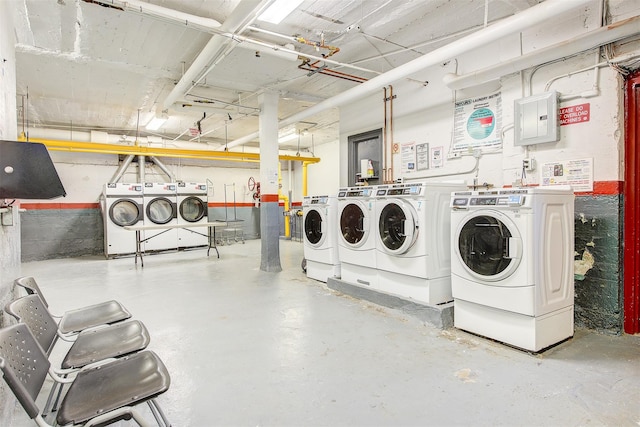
[378,200,418,255]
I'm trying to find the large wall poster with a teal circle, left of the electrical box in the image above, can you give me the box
[453,92,502,151]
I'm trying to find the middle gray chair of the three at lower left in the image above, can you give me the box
[5,295,151,413]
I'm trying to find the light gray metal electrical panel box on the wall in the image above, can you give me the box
[514,91,560,145]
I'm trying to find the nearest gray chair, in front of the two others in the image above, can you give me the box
[0,323,171,427]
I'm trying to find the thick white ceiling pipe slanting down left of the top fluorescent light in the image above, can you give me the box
[163,0,266,109]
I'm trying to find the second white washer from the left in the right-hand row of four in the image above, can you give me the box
[337,186,378,288]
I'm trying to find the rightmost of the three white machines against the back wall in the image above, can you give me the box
[178,182,209,248]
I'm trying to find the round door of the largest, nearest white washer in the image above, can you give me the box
[456,211,522,284]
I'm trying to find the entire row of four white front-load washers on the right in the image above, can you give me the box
[303,182,574,352]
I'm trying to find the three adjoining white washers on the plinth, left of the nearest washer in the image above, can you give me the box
[303,182,466,304]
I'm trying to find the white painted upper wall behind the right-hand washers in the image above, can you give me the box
[337,0,640,187]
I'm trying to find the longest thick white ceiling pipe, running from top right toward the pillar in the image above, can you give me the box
[228,0,591,148]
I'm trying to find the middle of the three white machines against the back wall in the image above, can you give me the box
[143,182,178,252]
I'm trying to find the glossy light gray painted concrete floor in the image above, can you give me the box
[8,240,640,427]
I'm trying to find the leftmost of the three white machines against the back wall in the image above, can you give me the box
[102,183,144,258]
